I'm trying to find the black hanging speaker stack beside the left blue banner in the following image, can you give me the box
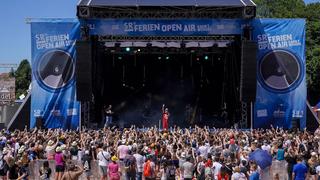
[76,40,92,102]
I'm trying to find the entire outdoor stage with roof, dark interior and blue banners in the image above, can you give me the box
[31,0,306,129]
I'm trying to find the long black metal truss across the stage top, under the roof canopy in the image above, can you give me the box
[77,6,255,19]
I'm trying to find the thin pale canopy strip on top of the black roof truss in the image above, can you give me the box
[78,0,256,7]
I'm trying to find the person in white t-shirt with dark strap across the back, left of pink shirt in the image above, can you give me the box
[97,146,110,180]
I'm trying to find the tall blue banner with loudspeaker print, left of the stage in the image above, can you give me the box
[30,19,80,129]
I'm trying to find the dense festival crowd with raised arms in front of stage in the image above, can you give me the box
[0,126,320,180]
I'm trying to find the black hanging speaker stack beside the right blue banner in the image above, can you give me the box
[240,40,258,102]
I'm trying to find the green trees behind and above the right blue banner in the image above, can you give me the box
[255,0,320,103]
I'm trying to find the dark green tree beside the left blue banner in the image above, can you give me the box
[14,59,31,97]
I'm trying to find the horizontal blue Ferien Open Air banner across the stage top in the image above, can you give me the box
[81,19,246,36]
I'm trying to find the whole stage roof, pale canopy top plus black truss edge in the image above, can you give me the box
[77,0,256,19]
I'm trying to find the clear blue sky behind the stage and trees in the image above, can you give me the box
[0,0,320,72]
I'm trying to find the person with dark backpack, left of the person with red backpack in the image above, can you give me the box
[124,150,137,180]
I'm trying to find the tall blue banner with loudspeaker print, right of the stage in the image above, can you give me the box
[252,19,307,129]
